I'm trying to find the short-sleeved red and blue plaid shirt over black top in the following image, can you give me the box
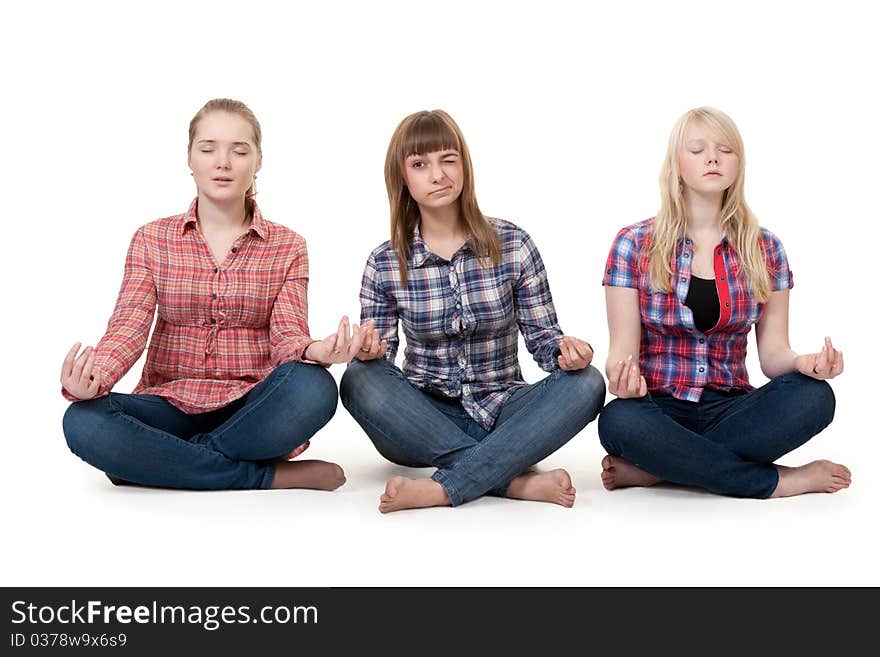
[602,218,793,401]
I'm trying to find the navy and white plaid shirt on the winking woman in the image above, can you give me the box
[360,218,562,429]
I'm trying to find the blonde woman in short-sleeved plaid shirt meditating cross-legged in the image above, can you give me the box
[599,107,851,498]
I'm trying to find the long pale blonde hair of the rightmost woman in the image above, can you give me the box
[648,107,770,302]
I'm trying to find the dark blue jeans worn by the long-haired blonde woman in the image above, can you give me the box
[599,372,834,498]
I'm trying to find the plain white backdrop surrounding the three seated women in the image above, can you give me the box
[0,0,880,586]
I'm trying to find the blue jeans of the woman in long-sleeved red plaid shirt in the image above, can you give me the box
[63,362,337,489]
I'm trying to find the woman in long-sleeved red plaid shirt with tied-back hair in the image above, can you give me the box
[61,98,361,490]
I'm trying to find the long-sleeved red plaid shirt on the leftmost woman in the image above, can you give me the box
[63,199,313,413]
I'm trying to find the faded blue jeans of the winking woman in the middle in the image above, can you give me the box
[339,358,605,506]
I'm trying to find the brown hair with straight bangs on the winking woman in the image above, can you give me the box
[385,110,501,284]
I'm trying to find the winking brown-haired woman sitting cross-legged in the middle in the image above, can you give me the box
[340,110,605,513]
